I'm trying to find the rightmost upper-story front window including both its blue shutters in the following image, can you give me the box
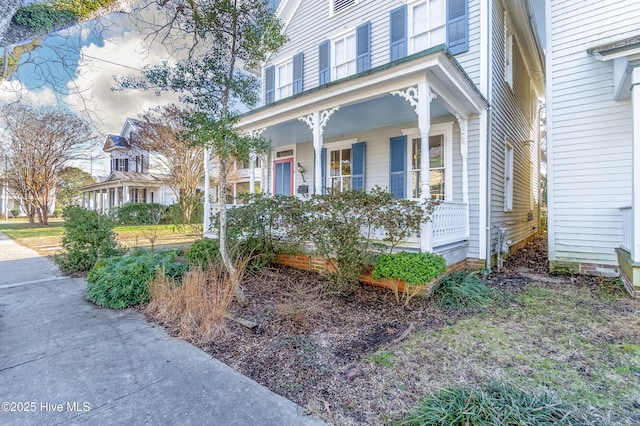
[389,0,469,61]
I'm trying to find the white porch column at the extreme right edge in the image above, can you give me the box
[631,65,640,262]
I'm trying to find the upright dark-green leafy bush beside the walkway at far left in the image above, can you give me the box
[56,206,122,272]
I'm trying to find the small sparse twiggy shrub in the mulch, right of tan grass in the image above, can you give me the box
[276,277,329,326]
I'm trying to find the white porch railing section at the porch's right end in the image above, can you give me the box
[431,202,469,247]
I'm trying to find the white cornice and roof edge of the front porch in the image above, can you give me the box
[239,45,488,135]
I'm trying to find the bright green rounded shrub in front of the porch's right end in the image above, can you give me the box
[371,251,447,285]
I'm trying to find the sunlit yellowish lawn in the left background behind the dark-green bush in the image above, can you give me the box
[0,218,201,256]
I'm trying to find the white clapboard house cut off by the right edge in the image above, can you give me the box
[546,0,640,295]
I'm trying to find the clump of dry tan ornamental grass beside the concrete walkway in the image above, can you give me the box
[145,261,247,343]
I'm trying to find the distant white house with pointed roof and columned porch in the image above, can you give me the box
[81,118,177,212]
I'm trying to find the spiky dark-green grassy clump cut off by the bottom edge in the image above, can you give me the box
[399,383,586,426]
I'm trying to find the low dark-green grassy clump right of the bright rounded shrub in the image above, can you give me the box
[433,271,494,310]
